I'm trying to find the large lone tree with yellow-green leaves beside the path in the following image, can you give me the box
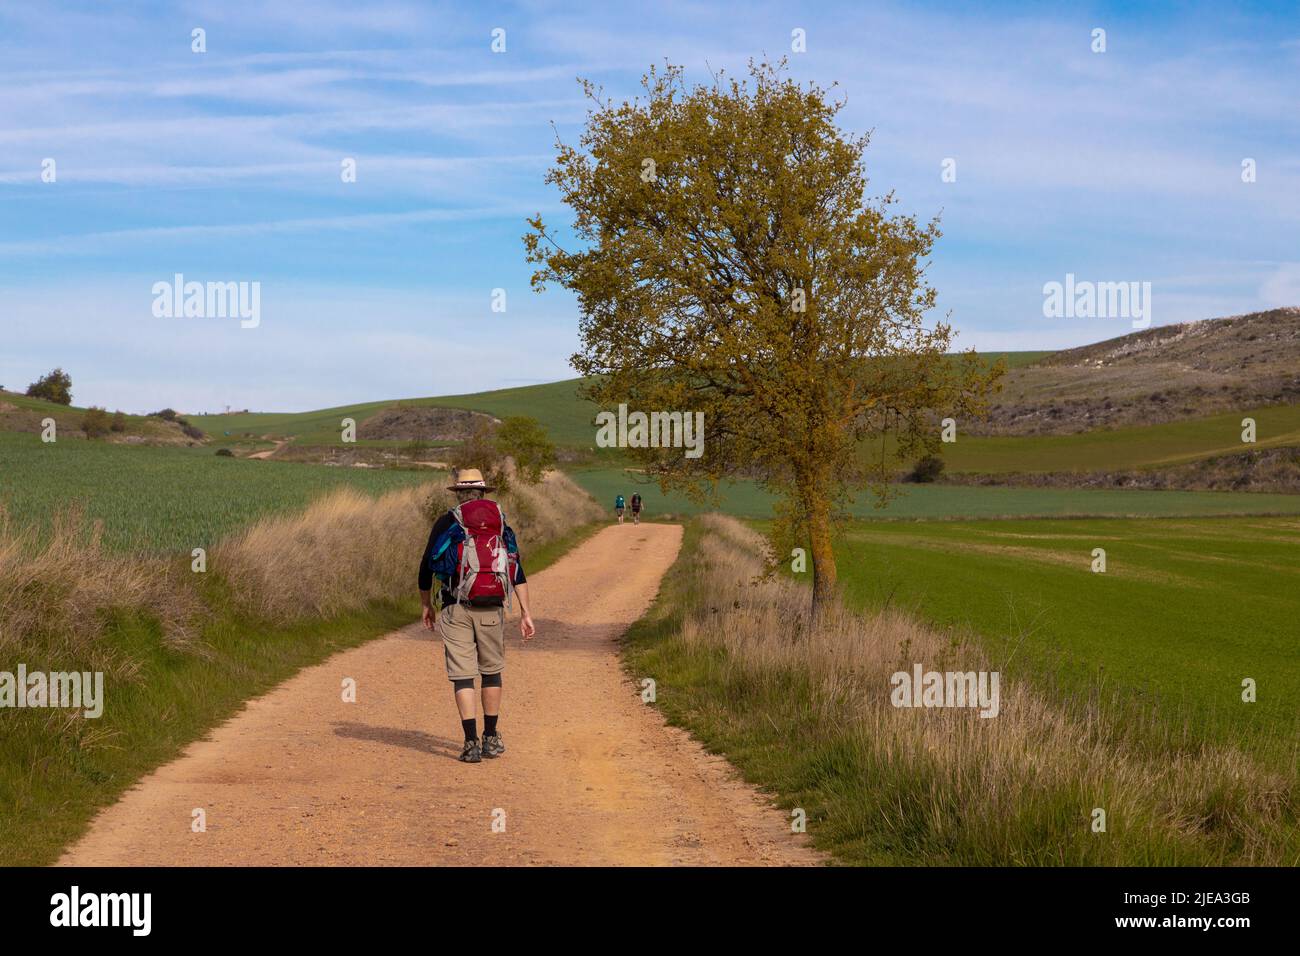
[524,61,1001,614]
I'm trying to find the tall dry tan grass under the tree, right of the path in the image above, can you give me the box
[681,516,1297,865]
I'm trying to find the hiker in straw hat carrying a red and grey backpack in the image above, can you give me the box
[420,468,537,763]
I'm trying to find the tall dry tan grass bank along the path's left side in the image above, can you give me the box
[0,472,602,660]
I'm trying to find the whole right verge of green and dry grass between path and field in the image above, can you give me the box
[625,518,1300,866]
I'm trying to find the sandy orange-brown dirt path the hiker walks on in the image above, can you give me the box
[60,524,820,865]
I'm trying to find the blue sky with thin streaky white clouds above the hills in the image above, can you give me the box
[0,0,1300,411]
